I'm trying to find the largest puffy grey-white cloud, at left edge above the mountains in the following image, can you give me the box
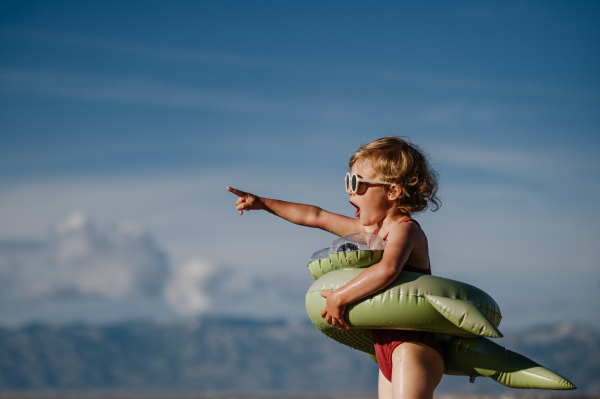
[0,213,169,302]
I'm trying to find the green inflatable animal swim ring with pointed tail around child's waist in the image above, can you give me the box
[306,244,576,390]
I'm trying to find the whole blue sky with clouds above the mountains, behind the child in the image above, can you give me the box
[0,1,600,327]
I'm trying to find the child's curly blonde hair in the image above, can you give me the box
[349,136,442,215]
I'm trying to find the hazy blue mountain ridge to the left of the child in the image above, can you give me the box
[0,320,377,390]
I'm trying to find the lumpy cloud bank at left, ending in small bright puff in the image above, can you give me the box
[0,213,220,321]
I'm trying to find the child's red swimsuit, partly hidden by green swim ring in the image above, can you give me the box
[373,218,444,382]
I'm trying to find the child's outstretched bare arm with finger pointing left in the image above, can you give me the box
[227,187,364,237]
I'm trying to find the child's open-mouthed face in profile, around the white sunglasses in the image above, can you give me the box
[348,161,394,226]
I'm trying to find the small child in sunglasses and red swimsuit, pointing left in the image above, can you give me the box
[227,137,444,399]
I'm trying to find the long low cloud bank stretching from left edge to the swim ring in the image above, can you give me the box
[0,212,312,325]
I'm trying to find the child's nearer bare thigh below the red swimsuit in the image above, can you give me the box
[390,342,444,399]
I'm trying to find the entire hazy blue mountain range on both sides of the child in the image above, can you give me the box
[0,318,600,393]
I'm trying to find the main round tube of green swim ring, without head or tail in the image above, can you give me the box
[306,268,502,340]
